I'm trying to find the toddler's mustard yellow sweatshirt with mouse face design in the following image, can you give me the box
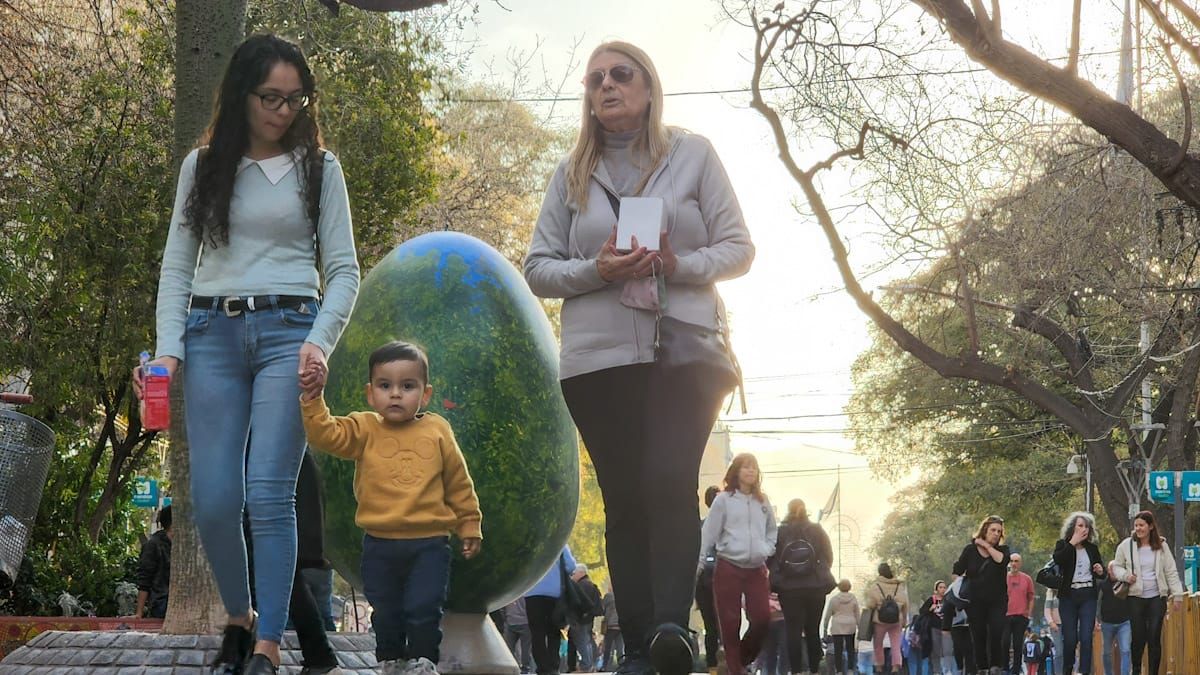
[300,396,484,539]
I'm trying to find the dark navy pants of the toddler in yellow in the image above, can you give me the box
[362,534,450,663]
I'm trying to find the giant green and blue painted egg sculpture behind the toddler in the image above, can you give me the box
[317,232,580,613]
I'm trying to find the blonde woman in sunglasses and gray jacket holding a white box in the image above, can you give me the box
[524,42,754,675]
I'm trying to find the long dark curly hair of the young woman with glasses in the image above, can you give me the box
[184,35,324,247]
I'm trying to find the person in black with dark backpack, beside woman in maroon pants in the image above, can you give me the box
[768,500,836,673]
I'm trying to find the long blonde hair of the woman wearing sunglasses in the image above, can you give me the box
[566,41,671,210]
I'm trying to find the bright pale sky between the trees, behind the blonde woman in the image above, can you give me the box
[446,0,1137,572]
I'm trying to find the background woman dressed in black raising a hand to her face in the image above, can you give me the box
[954,515,1012,675]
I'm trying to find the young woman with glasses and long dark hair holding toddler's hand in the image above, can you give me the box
[134,35,359,675]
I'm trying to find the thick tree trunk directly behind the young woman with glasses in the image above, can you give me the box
[162,0,246,634]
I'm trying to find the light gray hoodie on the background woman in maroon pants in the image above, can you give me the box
[700,490,776,568]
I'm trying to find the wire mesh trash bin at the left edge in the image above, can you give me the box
[0,410,54,586]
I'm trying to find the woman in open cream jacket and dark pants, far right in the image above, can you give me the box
[1112,510,1184,675]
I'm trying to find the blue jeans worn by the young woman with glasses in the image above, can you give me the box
[184,300,318,643]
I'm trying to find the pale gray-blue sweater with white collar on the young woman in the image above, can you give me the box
[155,145,359,360]
